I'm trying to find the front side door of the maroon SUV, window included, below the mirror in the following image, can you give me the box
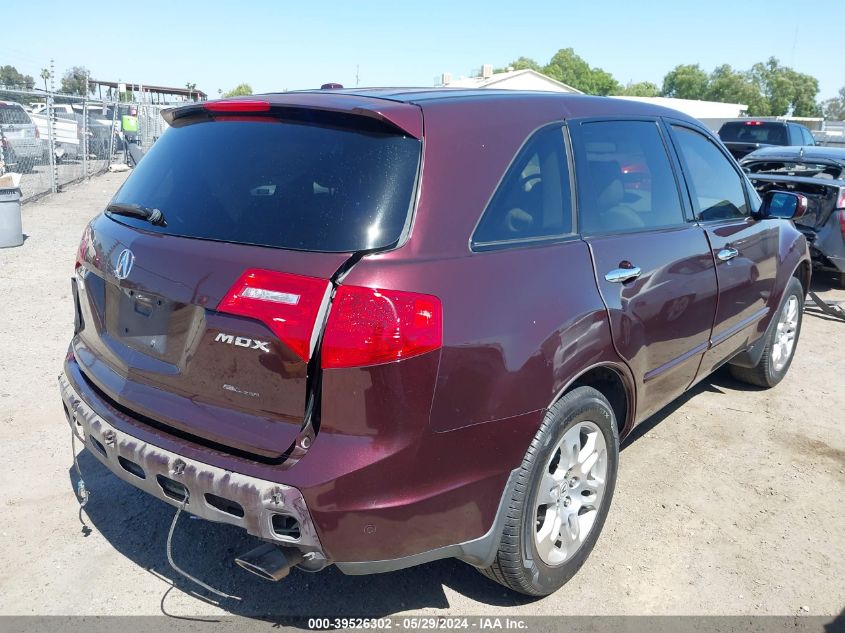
[670,122,780,371]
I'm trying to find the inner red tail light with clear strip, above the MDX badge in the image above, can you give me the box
[217,269,329,361]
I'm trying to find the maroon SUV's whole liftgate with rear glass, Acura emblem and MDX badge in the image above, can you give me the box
[74,105,421,459]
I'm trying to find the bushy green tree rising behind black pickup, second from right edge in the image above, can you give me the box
[749,57,821,116]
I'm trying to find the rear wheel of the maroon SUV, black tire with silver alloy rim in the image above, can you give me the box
[480,387,619,596]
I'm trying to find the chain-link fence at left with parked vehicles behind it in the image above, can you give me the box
[0,86,172,200]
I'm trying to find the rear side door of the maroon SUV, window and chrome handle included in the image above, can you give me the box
[571,119,717,420]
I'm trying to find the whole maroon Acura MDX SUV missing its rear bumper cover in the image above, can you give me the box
[59,89,811,595]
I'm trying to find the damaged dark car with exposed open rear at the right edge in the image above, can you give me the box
[741,147,845,287]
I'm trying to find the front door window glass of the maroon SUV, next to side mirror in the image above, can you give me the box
[672,126,748,222]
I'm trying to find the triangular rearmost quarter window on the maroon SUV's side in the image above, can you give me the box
[472,126,572,245]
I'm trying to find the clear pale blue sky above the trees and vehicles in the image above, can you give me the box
[0,0,845,99]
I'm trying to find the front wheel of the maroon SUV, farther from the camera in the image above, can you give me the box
[730,277,804,389]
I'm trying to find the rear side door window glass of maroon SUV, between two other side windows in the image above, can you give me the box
[578,121,684,234]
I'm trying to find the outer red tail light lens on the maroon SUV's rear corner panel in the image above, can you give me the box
[322,286,443,369]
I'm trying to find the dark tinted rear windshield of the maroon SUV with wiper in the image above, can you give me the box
[112,117,421,252]
